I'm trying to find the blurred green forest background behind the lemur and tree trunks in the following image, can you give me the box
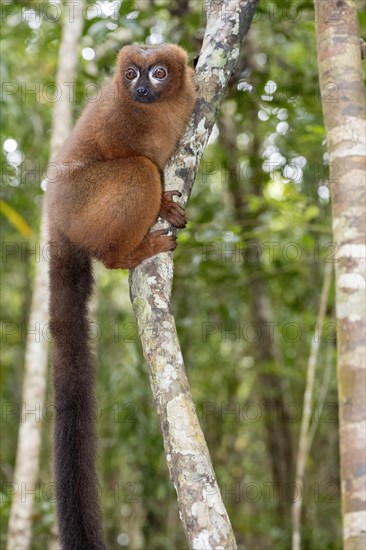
[0,0,365,550]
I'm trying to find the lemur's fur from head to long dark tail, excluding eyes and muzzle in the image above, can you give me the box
[47,45,195,550]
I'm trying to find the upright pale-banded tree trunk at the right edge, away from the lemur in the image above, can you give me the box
[316,0,366,550]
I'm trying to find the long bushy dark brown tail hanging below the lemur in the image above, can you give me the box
[50,238,106,550]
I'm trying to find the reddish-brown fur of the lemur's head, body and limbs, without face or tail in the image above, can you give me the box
[48,45,195,268]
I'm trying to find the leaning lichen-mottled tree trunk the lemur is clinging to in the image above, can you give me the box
[130,0,258,550]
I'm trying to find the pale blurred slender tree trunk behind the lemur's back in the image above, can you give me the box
[7,5,83,550]
